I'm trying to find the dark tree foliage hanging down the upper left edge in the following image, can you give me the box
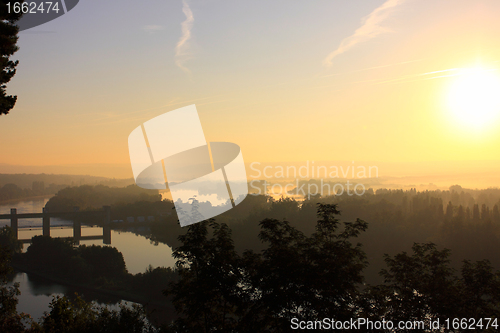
[0,0,23,115]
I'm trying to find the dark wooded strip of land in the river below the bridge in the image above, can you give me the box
[13,236,178,306]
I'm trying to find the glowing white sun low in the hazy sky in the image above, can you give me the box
[447,67,500,130]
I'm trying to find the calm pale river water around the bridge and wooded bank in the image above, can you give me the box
[0,198,175,320]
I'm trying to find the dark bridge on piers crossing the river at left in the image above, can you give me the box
[0,206,111,244]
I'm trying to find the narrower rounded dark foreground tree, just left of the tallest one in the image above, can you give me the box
[164,220,243,332]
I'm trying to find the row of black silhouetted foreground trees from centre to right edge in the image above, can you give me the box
[165,204,500,332]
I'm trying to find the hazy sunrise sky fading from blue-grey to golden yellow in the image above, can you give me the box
[0,0,500,186]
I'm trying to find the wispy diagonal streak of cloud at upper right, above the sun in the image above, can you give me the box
[323,0,406,67]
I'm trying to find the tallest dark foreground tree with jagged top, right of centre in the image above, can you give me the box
[245,203,368,332]
